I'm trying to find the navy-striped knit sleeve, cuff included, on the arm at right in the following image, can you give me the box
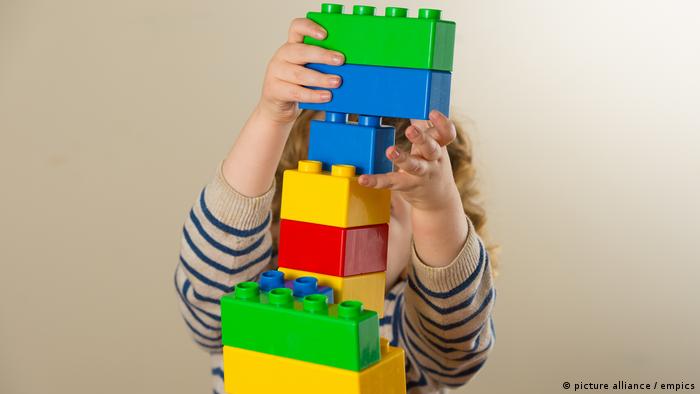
[383,217,496,393]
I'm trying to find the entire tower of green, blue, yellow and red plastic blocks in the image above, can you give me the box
[221,4,455,394]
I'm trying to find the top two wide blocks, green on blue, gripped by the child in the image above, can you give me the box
[301,4,455,119]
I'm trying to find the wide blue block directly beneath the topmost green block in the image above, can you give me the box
[299,64,452,119]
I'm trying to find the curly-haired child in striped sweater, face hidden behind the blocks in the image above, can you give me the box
[175,19,495,393]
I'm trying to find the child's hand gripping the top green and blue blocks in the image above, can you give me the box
[258,18,345,124]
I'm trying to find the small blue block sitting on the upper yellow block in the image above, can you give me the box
[309,112,394,175]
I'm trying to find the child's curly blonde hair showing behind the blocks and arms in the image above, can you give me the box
[272,110,498,272]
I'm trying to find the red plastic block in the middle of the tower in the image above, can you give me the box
[278,219,389,276]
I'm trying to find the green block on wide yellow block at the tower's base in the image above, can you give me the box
[221,282,406,394]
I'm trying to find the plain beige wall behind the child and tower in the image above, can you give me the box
[0,0,700,394]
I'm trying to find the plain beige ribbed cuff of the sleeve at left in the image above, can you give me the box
[200,162,275,230]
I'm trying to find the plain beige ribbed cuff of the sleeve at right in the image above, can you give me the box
[411,218,485,292]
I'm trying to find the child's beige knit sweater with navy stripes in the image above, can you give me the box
[175,165,495,394]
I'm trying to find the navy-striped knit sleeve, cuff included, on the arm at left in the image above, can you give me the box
[175,163,275,352]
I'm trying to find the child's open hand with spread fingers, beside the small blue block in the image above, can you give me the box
[358,111,461,211]
